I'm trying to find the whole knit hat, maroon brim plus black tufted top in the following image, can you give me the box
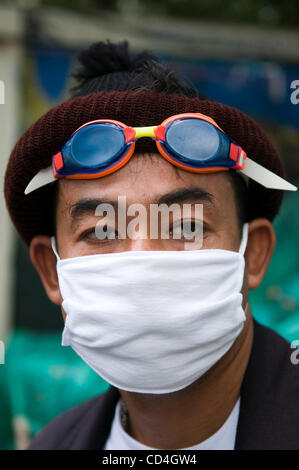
[4,42,285,245]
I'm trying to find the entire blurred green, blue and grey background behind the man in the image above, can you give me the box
[0,0,299,449]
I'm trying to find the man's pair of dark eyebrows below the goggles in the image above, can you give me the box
[68,187,215,224]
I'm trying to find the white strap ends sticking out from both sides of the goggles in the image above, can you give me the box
[24,157,297,194]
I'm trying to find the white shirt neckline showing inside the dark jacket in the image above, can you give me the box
[105,399,240,450]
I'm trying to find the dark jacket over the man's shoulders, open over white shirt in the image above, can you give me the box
[28,321,299,450]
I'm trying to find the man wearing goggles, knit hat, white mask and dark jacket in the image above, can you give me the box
[5,43,299,450]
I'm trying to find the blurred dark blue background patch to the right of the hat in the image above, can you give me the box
[173,57,299,128]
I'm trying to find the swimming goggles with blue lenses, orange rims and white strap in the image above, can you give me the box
[25,113,297,194]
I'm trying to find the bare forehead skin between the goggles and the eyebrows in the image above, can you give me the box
[58,153,235,216]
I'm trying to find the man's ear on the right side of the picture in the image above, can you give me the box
[245,218,276,290]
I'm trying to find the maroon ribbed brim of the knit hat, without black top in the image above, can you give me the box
[4,90,285,245]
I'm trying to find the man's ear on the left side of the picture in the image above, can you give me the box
[29,235,62,305]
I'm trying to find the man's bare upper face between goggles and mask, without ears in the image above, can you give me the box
[56,154,240,258]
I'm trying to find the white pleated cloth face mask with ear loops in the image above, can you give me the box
[52,224,247,394]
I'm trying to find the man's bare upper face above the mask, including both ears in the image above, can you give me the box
[30,154,275,320]
